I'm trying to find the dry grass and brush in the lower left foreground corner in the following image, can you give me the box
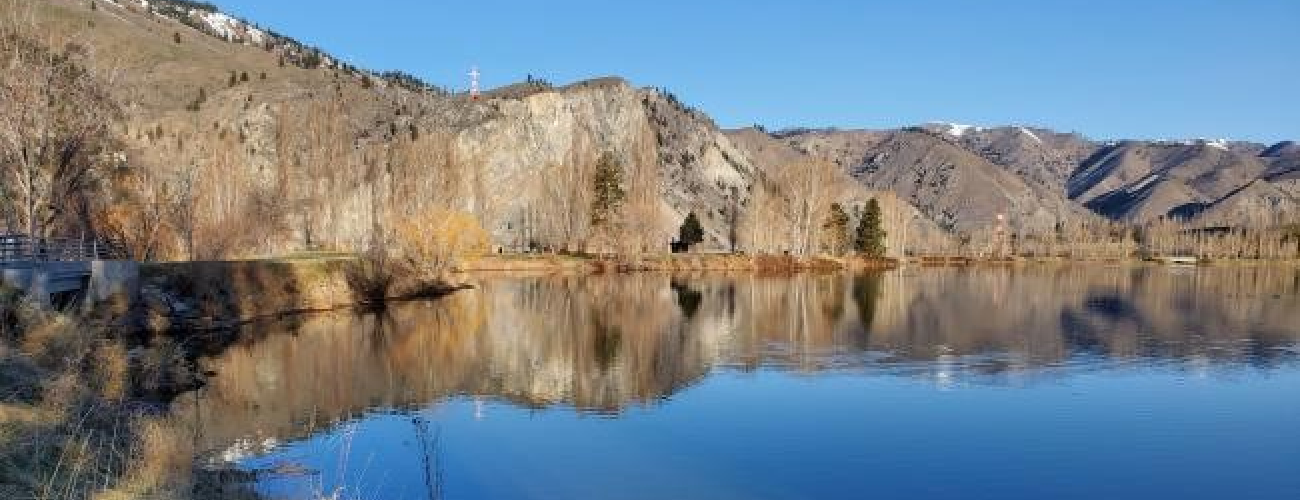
[0,296,202,500]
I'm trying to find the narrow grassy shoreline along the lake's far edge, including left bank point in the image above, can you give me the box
[88,253,1300,332]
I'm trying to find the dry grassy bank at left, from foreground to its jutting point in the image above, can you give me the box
[0,257,458,500]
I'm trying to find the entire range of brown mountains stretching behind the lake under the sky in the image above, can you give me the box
[4,0,1300,251]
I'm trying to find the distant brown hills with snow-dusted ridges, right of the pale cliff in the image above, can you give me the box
[733,122,1300,234]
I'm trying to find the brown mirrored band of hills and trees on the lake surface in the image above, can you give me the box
[176,266,1300,467]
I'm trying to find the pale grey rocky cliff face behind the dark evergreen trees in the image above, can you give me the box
[434,78,754,249]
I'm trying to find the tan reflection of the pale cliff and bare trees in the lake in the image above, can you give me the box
[174,275,714,449]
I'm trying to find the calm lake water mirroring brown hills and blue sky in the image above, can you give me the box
[176,268,1300,500]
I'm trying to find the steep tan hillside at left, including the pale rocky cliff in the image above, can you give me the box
[10,0,754,257]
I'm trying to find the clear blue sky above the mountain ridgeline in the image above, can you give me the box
[216,0,1300,142]
